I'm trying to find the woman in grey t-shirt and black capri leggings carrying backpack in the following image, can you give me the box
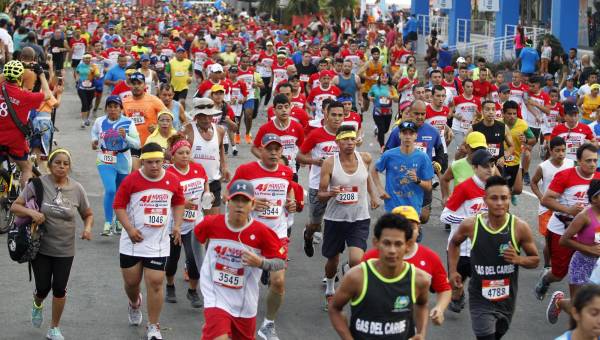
[11,149,94,340]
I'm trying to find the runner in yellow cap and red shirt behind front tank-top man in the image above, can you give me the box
[362,206,452,325]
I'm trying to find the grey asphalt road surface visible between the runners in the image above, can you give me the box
[0,77,568,340]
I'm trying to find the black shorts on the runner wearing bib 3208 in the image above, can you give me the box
[321,219,371,259]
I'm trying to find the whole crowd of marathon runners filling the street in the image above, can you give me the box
[0,1,600,340]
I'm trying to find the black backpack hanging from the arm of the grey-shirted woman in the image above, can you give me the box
[6,178,46,281]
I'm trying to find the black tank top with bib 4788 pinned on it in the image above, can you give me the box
[469,214,520,313]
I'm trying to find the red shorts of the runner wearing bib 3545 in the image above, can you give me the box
[202,307,256,340]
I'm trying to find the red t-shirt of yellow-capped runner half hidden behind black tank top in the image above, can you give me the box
[362,244,452,293]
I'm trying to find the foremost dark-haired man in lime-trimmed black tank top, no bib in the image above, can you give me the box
[329,214,430,340]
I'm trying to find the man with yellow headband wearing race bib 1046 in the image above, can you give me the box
[113,143,185,340]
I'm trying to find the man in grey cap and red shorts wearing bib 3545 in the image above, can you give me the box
[194,180,287,340]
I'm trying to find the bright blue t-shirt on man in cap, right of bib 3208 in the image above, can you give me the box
[375,148,433,213]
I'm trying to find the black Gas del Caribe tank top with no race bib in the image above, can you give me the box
[350,259,416,340]
